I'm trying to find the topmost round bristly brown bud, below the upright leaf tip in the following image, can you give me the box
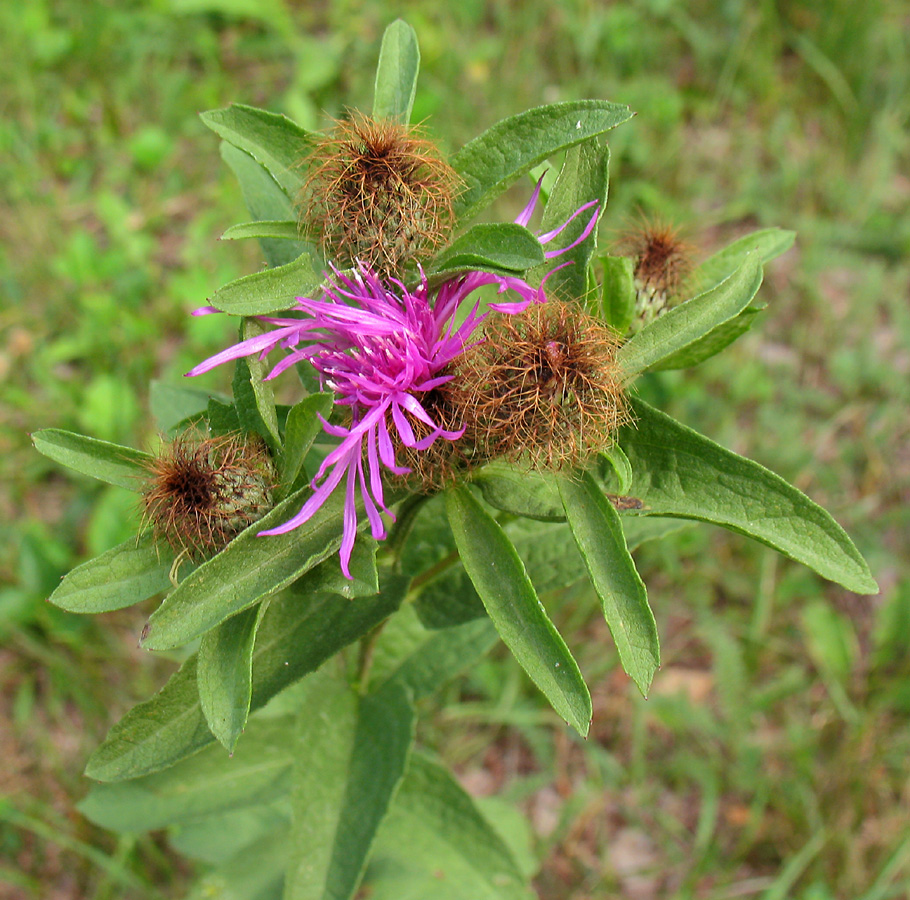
[297,112,459,276]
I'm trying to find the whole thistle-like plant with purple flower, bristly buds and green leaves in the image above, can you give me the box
[34,21,877,900]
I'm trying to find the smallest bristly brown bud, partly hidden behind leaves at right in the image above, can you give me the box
[618,220,692,331]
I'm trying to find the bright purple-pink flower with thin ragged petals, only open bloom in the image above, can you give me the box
[187,182,597,578]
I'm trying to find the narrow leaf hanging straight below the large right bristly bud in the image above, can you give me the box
[559,474,660,696]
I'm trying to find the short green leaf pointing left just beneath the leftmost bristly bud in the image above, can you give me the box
[48,533,174,613]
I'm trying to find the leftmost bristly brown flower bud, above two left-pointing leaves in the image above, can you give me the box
[142,435,273,560]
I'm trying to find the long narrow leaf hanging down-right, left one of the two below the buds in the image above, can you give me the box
[446,487,591,736]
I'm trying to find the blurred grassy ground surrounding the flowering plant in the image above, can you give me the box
[0,0,910,900]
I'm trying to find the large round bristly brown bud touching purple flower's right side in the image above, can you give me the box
[458,300,629,469]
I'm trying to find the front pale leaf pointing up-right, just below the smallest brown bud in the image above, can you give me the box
[617,253,762,376]
